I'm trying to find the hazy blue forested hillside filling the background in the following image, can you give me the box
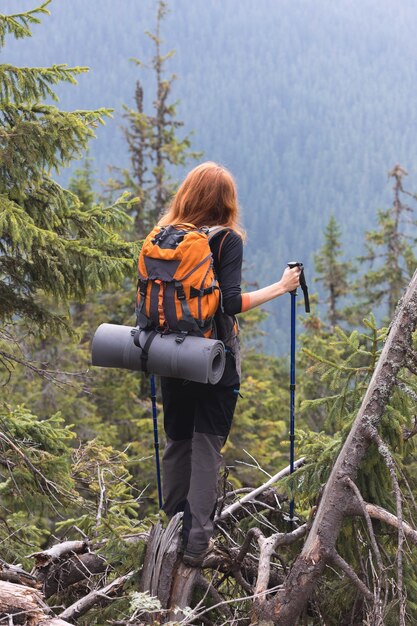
[2,0,417,352]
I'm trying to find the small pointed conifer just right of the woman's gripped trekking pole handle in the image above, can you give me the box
[314,215,352,329]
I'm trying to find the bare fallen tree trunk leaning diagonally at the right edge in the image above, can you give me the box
[256,272,417,626]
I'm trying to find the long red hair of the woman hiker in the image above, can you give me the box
[158,161,244,237]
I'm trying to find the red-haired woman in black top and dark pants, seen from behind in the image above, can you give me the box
[159,162,300,567]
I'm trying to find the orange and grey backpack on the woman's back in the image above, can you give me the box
[136,224,224,338]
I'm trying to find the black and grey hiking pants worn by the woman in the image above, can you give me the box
[161,370,239,554]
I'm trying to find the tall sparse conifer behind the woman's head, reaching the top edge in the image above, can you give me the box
[110,0,199,237]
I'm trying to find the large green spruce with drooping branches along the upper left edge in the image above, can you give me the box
[0,2,133,363]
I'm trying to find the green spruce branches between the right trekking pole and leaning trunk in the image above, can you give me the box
[296,316,386,509]
